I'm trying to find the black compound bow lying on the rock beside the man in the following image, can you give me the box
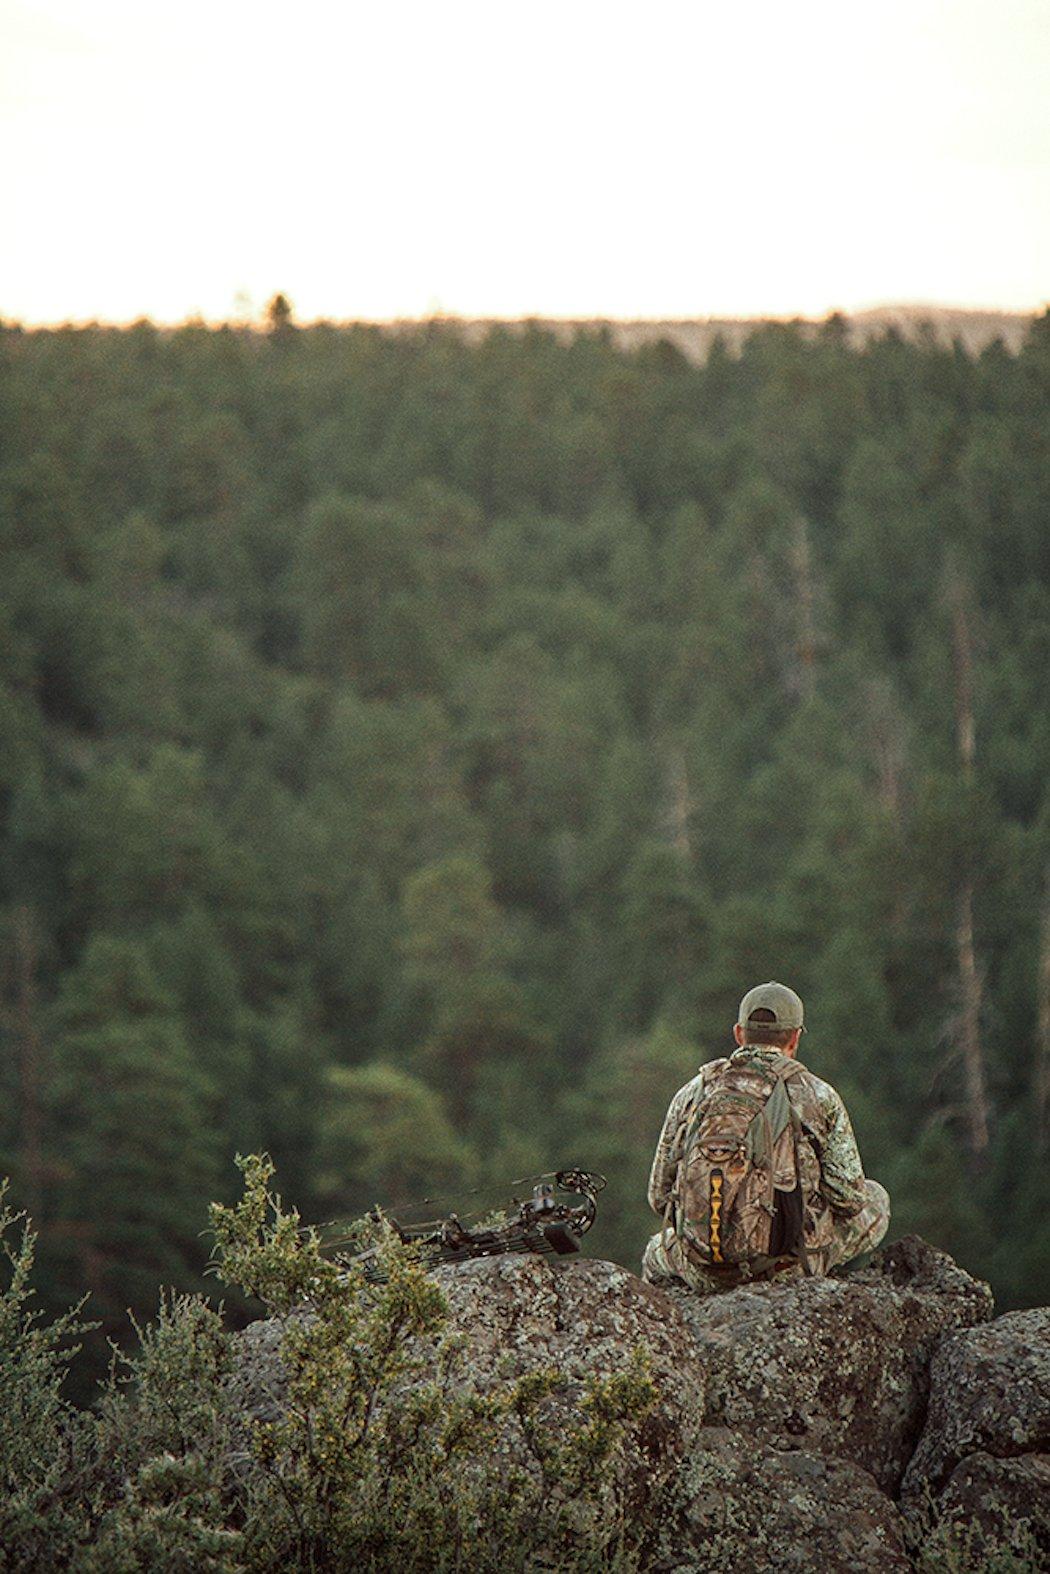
[353,1169,606,1281]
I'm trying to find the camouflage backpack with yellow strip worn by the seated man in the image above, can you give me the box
[674,1058,826,1273]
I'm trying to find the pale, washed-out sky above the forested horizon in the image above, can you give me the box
[0,0,1050,323]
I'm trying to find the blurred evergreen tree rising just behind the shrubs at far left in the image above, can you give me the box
[43,933,217,1359]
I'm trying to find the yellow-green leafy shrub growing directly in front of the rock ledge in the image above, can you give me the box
[213,1158,655,1569]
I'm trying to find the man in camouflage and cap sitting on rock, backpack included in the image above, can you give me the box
[642,982,889,1294]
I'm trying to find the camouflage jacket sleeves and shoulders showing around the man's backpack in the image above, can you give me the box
[649,1045,867,1218]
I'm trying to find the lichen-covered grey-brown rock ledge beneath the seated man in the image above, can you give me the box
[242,1237,1050,1574]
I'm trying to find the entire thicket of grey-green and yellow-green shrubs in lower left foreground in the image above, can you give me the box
[0,1157,655,1574]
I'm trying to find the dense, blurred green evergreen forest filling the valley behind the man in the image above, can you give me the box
[0,312,1050,1391]
